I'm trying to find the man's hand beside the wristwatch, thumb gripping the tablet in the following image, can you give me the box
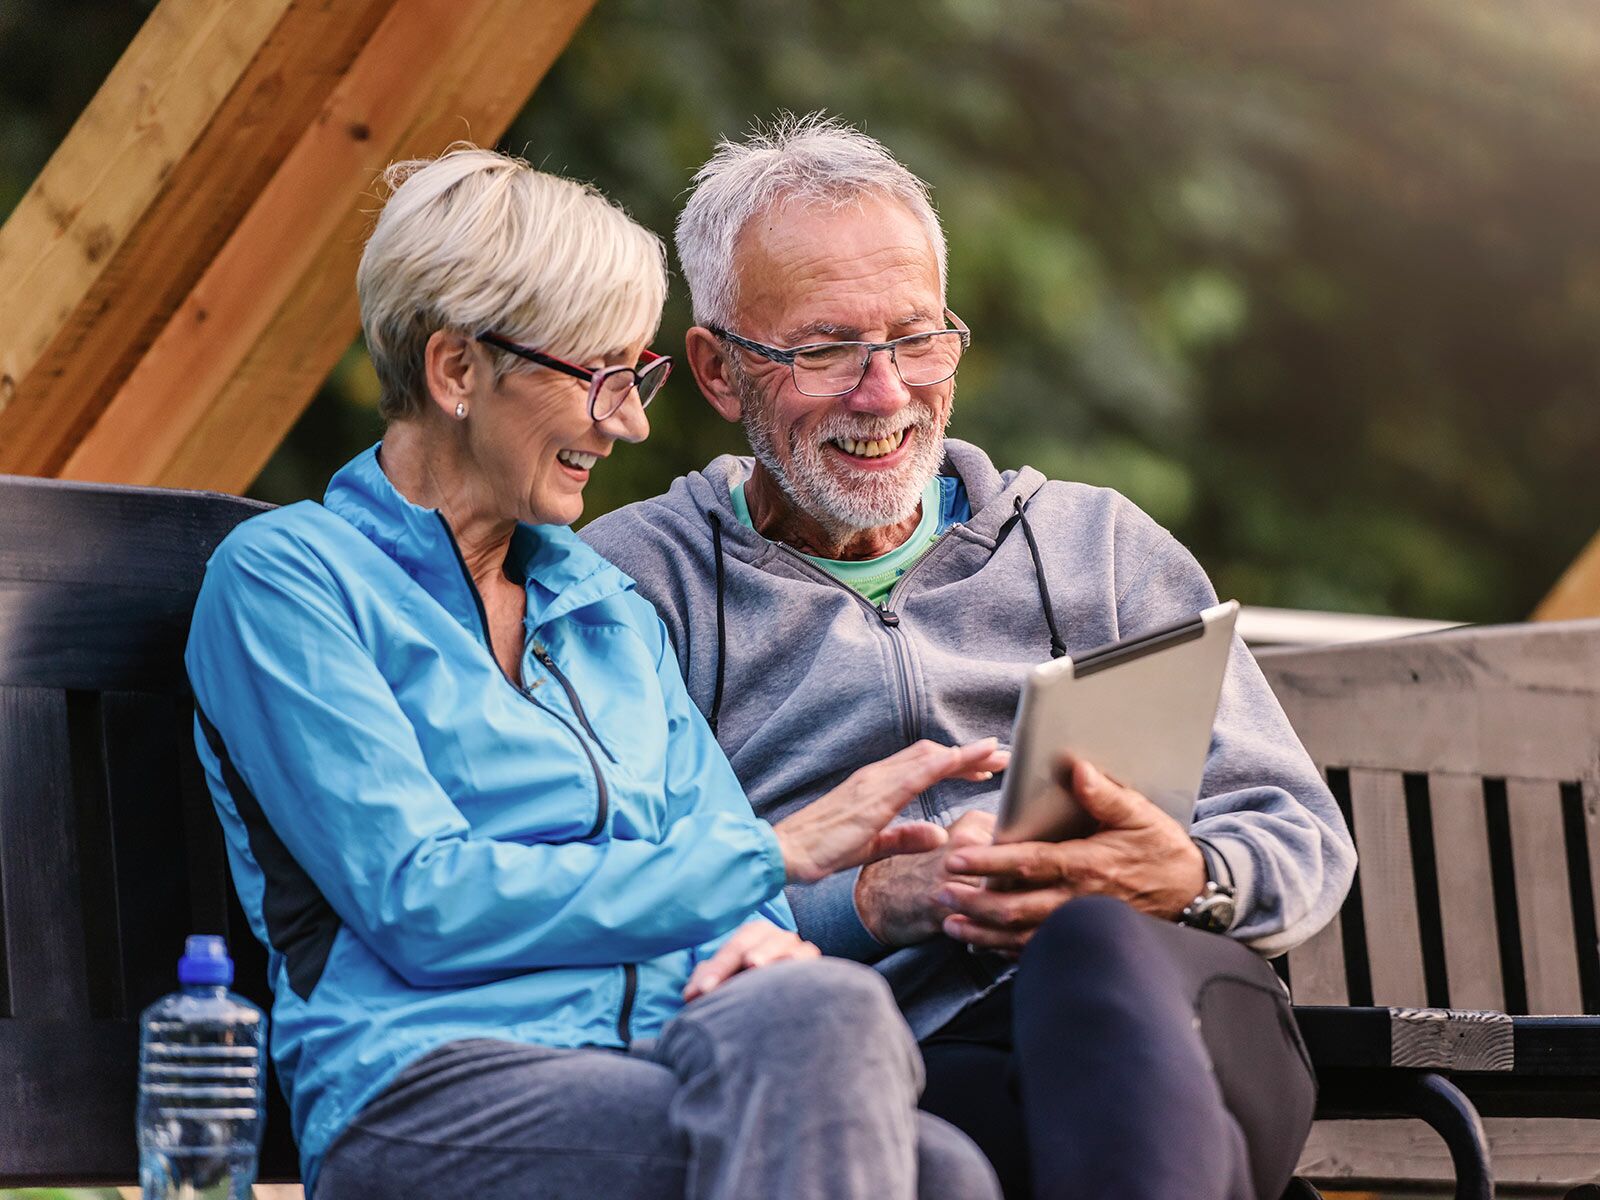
[939,757,1206,954]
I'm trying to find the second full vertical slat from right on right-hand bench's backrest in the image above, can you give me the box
[1427,773,1506,1010]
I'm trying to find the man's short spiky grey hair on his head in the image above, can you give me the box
[677,112,947,325]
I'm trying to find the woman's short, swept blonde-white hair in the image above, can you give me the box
[355,142,667,421]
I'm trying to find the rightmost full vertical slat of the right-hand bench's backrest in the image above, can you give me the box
[1506,779,1584,1016]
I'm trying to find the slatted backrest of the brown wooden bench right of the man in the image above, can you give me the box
[1259,621,1600,1014]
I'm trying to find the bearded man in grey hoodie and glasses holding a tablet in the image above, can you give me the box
[586,117,1355,1200]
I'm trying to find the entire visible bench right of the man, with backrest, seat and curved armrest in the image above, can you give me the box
[1259,621,1600,1197]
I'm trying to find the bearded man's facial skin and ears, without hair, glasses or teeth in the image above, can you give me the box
[688,197,955,560]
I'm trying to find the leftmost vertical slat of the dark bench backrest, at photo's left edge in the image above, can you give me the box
[0,688,90,1017]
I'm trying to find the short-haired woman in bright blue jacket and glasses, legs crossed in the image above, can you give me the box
[187,147,1003,1200]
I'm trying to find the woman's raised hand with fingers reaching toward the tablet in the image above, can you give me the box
[773,738,1010,883]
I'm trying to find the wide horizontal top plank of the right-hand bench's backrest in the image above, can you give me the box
[1258,621,1600,781]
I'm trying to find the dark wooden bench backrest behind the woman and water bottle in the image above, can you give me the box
[0,475,294,1186]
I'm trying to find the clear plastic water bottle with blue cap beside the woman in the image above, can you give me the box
[139,934,267,1200]
